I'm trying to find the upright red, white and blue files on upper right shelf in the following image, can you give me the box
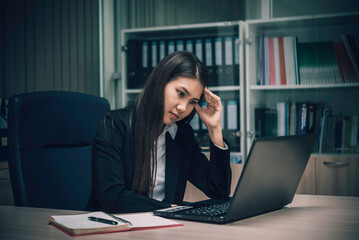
[257,35,299,85]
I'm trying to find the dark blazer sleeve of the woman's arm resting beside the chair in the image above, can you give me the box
[92,109,171,213]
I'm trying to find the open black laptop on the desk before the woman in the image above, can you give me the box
[153,134,317,223]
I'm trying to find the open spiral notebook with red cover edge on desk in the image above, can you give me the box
[49,212,183,236]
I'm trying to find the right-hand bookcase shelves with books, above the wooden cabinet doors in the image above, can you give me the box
[245,12,359,158]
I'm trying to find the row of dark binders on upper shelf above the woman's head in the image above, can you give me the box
[127,35,239,89]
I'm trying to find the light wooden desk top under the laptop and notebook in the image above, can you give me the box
[0,195,359,240]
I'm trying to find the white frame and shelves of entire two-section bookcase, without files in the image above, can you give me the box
[122,12,359,165]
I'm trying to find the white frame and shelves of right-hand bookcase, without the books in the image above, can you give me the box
[245,12,359,155]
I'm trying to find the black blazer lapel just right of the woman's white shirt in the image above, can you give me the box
[165,132,181,203]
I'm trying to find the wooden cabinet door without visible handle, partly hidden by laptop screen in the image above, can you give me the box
[296,155,316,194]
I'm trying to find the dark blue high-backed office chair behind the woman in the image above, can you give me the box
[8,91,110,210]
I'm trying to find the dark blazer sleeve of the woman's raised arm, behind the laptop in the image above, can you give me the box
[188,126,232,199]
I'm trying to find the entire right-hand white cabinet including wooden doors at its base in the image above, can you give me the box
[245,12,359,199]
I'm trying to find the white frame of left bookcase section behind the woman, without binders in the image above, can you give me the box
[122,21,246,163]
